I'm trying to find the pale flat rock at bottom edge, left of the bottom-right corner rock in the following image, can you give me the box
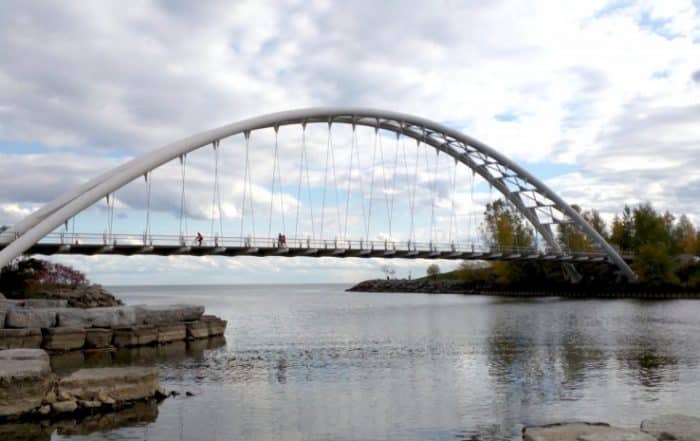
[523,422,655,441]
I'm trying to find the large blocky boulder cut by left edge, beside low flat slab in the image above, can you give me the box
[0,349,53,417]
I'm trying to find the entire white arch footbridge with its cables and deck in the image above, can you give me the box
[0,108,635,280]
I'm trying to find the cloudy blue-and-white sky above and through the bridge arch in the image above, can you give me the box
[0,0,700,285]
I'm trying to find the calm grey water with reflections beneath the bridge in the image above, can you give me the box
[12,285,700,441]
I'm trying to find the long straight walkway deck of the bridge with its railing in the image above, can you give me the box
[0,233,607,262]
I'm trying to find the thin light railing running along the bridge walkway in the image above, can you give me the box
[30,232,602,257]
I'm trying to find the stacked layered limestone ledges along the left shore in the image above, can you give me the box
[0,288,227,422]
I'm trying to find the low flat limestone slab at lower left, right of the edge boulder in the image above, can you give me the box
[57,367,160,403]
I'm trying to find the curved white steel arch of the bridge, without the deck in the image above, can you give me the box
[0,107,636,281]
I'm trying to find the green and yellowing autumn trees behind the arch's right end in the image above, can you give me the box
[459,199,700,289]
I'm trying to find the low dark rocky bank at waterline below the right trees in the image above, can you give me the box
[346,277,700,299]
